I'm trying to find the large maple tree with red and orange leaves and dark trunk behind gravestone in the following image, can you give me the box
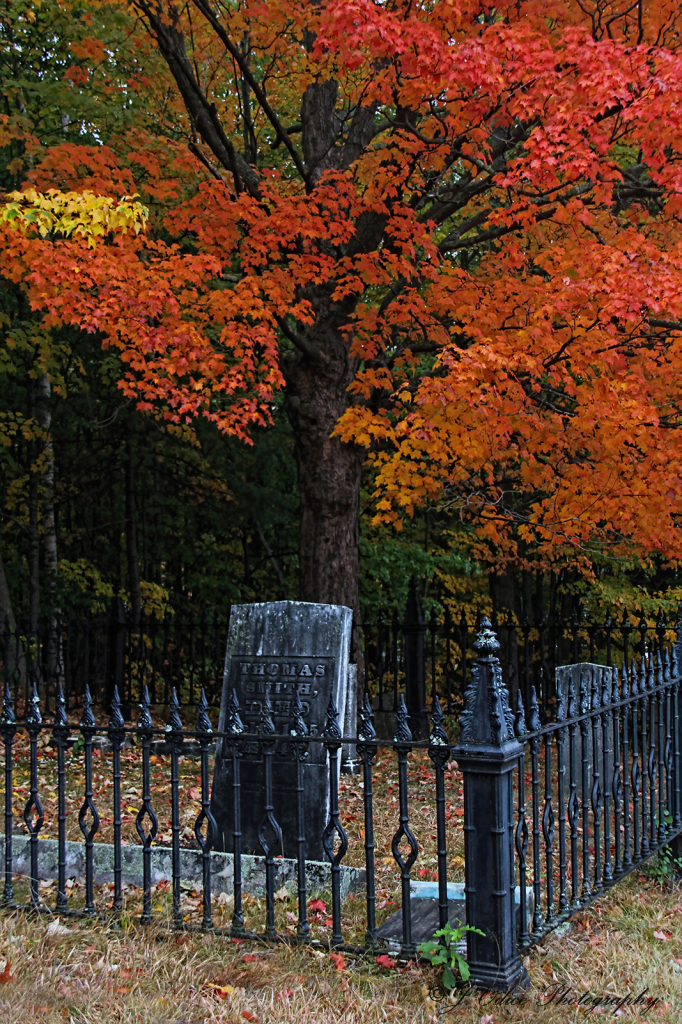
[2,0,682,634]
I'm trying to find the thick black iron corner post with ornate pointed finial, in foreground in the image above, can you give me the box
[453,618,529,991]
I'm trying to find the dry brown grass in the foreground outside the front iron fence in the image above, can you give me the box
[0,872,682,1024]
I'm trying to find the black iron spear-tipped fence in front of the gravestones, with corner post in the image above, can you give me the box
[0,620,682,989]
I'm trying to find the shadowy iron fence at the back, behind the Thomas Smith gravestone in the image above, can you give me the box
[5,579,672,722]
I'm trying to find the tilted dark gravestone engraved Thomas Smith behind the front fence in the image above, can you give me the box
[211,601,355,860]
